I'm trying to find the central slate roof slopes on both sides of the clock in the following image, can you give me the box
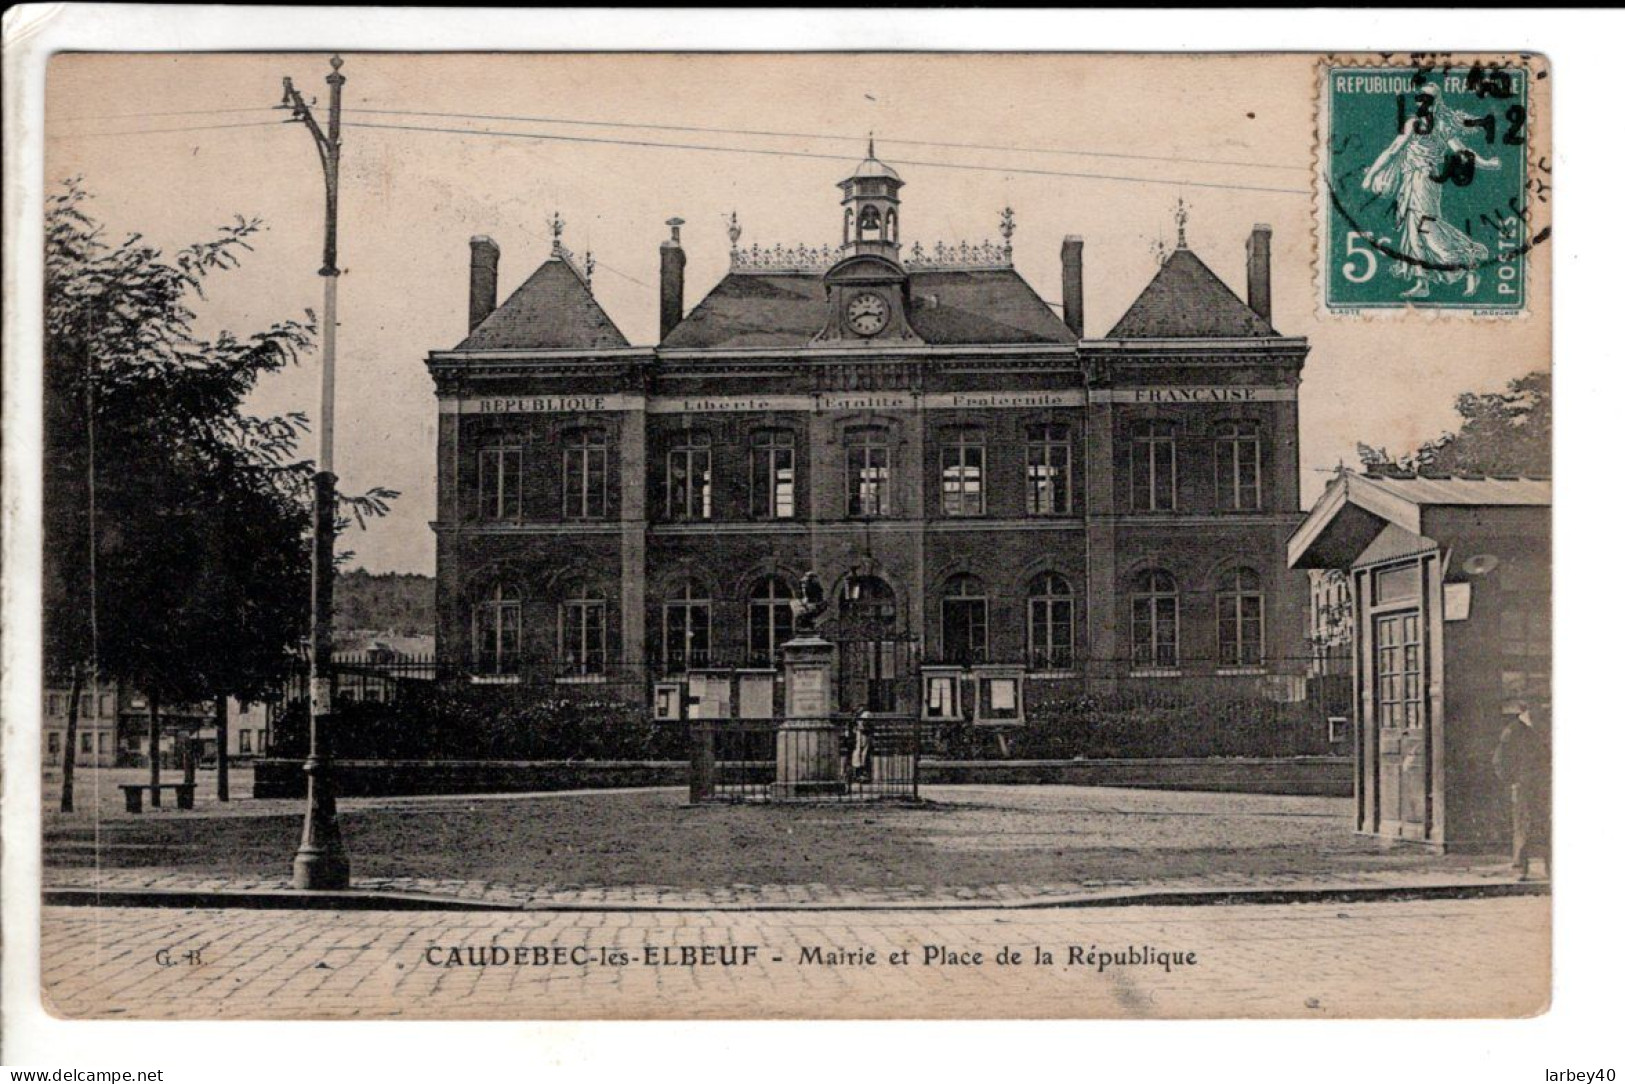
[661,268,1077,349]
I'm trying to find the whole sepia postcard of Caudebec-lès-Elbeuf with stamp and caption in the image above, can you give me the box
[19,50,1557,1021]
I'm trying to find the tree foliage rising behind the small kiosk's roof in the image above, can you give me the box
[1359,372,1552,476]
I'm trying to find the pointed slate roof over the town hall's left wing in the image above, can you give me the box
[457,257,629,349]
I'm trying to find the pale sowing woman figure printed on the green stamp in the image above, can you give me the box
[1360,83,1502,297]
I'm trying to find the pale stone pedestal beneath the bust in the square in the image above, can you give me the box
[772,634,847,798]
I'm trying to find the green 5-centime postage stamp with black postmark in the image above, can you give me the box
[1320,65,1545,312]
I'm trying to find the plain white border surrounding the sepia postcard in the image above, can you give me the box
[0,5,1625,1084]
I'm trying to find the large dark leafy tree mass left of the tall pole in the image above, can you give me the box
[44,180,397,809]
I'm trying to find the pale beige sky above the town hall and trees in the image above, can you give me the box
[46,54,1550,574]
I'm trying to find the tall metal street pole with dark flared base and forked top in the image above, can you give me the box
[283,57,349,889]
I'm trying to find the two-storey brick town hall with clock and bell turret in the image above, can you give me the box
[427,146,1308,722]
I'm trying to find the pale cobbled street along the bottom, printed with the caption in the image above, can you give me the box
[42,897,1550,1019]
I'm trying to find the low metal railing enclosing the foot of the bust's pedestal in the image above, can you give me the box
[689,717,921,803]
